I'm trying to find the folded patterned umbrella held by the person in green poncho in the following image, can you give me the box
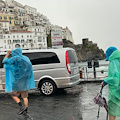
[93,86,108,120]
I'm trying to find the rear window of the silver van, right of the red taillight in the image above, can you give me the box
[68,50,78,63]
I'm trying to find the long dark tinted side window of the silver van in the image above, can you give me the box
[23,52,60,65]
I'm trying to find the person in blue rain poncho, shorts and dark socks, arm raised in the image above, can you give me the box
[3,48,35,115]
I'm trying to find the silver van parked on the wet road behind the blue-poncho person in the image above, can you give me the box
[0,48,80,95]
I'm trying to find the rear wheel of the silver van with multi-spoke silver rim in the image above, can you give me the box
[39,80,57,96]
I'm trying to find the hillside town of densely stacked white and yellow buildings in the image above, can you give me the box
[0,0,73,51]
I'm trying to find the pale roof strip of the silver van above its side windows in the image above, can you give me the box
[0,47,74,55]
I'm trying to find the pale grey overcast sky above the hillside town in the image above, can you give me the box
[15,0,120,51]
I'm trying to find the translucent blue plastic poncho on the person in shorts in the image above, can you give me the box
[3,48,35,92]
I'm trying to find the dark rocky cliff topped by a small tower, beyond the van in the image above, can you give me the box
[63,38,105,61]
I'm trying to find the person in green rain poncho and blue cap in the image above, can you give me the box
[101,47,120,120]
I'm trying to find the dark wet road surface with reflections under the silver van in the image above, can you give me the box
[0,83,120,120]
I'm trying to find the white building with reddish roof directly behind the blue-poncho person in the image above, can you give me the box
[0,31,34,51]
